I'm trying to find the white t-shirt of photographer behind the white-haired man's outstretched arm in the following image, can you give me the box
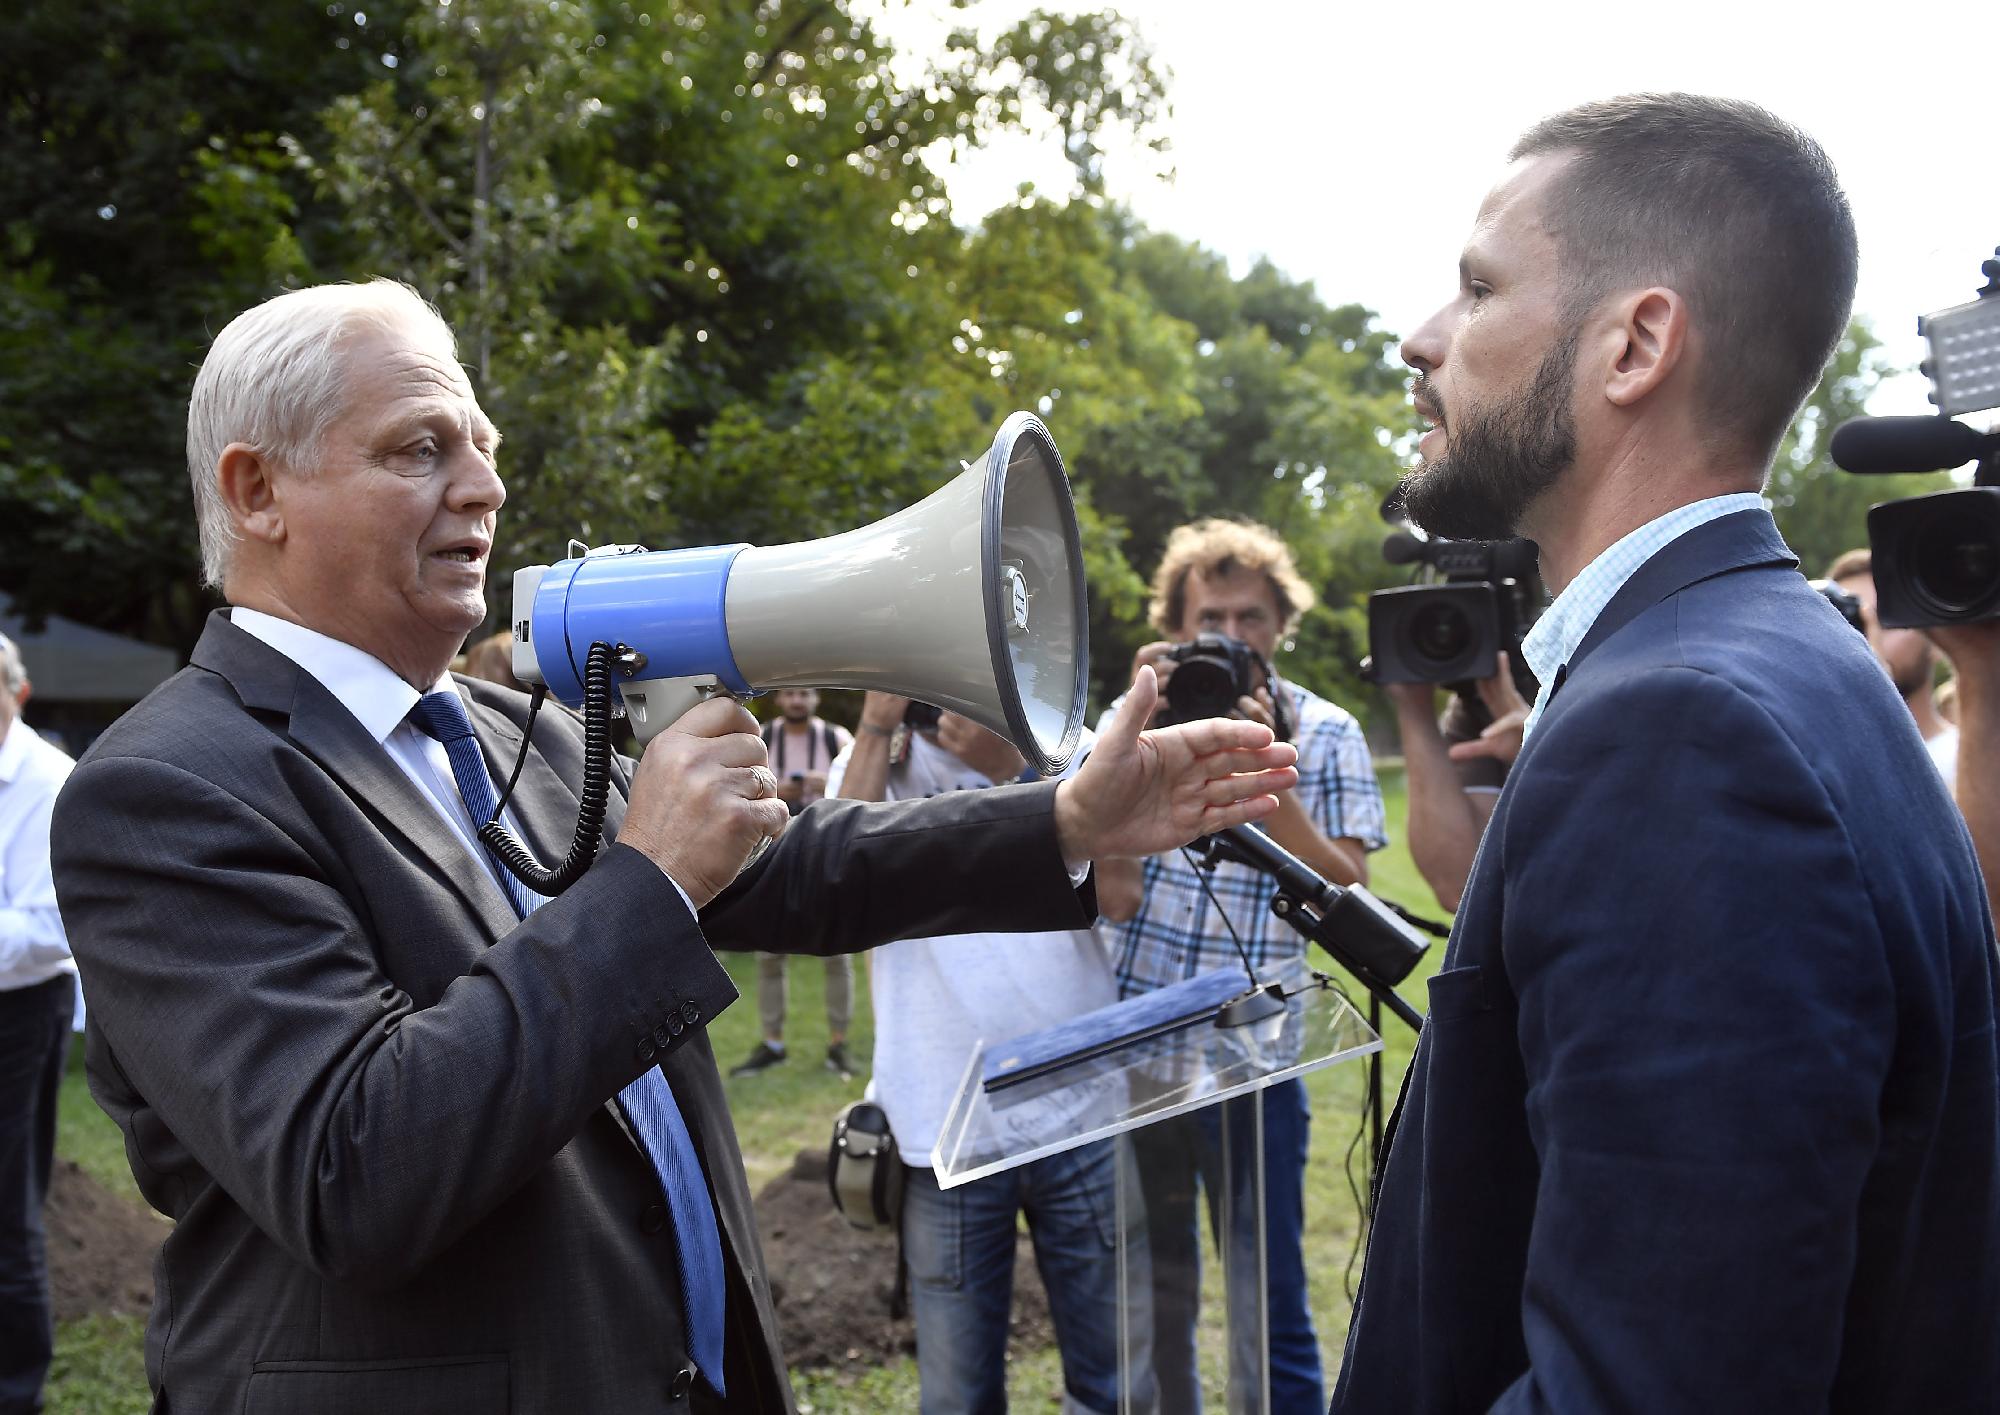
[826,733,1118,1167]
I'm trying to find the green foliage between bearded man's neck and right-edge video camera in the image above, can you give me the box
[1766,320,1952,576]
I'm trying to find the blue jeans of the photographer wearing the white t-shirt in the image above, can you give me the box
[902,1141,1118,1415]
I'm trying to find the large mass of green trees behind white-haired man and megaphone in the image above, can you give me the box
[0,0,1408,731]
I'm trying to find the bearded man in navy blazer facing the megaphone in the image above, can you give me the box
[1334,94,2000,1415]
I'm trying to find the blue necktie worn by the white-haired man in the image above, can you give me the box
[410,692,724,1395]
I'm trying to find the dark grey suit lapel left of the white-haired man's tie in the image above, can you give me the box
[192,612,520,941]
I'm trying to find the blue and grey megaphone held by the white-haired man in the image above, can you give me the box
[514,412,1090,775]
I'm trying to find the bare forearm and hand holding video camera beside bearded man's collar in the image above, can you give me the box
[1384,650,1528,911]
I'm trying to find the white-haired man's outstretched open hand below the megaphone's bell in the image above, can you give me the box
[1056,668,1298,869]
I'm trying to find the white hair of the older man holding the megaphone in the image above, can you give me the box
[188,280,458,586]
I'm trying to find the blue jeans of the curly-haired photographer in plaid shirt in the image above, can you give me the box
[1132,1079,1326,1415]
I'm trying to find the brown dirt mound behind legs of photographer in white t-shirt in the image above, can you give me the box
[756,1149,1056,1367]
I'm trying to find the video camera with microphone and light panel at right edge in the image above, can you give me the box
[1828,248,2000,630]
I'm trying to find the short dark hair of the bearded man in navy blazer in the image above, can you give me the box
[1508,94,1860,462]
